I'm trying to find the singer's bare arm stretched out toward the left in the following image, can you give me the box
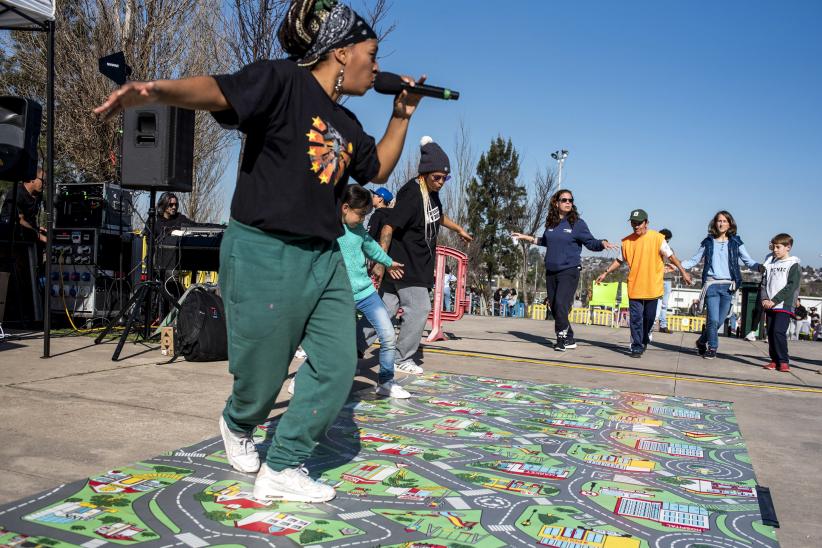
[94,76,231,120]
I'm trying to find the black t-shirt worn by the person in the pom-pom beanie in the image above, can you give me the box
[386,179,442,288]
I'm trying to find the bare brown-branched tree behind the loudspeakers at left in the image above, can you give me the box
[0,0,232,220]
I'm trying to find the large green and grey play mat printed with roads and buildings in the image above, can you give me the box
[0,374,778,548]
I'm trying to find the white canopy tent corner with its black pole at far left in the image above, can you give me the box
[0,0,56,358]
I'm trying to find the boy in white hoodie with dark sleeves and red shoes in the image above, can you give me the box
[759,233,802,372]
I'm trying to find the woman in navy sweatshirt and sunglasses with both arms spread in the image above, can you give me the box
[512,189,619,352]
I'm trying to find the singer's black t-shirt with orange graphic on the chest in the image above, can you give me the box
[213,60,380,241]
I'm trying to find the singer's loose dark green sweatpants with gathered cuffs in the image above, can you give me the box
[220,220,357,471]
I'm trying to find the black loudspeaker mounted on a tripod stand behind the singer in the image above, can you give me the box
[120,105,194,192]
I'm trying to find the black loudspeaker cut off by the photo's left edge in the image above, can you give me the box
[0,95,43,181]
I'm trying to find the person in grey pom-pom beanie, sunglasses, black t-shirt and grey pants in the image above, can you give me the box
[370,137,473,375]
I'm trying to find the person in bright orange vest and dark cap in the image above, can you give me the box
[597,209,691,358]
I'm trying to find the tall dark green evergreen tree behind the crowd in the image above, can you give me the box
[468,137,526,292]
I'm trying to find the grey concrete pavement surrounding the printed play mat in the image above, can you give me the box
[0,317,822,547]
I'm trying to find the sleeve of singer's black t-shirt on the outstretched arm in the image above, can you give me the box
[212,61,291,133]
